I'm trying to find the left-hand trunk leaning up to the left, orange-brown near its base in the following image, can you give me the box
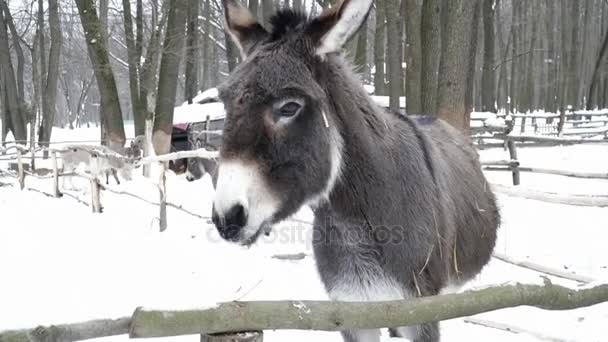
[76,0,126,148]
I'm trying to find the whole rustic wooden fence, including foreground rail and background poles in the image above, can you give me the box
[0,140,608,342]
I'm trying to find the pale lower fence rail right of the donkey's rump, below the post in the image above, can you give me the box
[492,184,608,207]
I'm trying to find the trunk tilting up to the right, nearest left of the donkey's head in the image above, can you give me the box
[152,0,187,155]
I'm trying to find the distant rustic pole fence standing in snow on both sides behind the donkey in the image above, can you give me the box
[0,121,608,223]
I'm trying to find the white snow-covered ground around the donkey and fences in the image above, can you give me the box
[0,128,608,342]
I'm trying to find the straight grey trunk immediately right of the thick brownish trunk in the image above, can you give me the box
[481,0,496,113]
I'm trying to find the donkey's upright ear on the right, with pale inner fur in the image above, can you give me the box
[309,0,374,56]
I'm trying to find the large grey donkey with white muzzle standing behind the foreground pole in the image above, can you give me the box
[212,0,499,342]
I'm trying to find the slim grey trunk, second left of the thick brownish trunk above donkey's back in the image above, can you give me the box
[404,0,422,114]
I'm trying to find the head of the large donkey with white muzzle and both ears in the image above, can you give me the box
[213,0,372,245]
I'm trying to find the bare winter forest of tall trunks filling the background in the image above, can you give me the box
[0,0,608,152]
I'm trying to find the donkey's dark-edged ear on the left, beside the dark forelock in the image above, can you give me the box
[222,0,268,58]
